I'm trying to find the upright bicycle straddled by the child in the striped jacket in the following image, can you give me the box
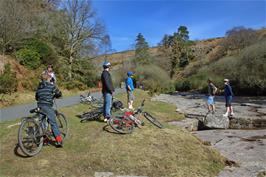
[18,108,68,156]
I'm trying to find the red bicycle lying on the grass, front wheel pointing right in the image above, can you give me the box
[108,100,163,134]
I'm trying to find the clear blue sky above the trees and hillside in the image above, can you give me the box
[92,0,266,51]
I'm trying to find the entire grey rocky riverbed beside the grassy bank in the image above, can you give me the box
[153,93,266,177]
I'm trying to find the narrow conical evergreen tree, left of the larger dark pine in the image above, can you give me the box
[135,33,150,64]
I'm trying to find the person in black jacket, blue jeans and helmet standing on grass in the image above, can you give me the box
[101,61,115,122]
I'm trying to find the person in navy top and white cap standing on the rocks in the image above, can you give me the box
[223,79,234,117]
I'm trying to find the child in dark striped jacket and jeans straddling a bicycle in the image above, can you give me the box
[35,72,63,147]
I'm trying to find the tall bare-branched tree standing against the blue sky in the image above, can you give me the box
[63,0,105,79]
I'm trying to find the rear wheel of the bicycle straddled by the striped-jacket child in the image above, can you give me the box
[18,118,43,156]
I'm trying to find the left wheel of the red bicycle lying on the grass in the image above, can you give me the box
[108,117,134,134]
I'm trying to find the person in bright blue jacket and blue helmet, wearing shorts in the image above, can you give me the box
[125,71,135,109]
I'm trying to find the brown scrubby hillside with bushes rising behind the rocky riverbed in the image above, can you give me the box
[94,28,266,95]
